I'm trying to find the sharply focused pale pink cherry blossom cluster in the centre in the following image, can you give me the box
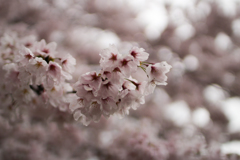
[70,45,171,125]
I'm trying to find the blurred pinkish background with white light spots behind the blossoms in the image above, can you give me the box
[0,0,240,160]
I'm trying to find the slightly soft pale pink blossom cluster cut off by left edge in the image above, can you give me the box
[0,32,76,110]
